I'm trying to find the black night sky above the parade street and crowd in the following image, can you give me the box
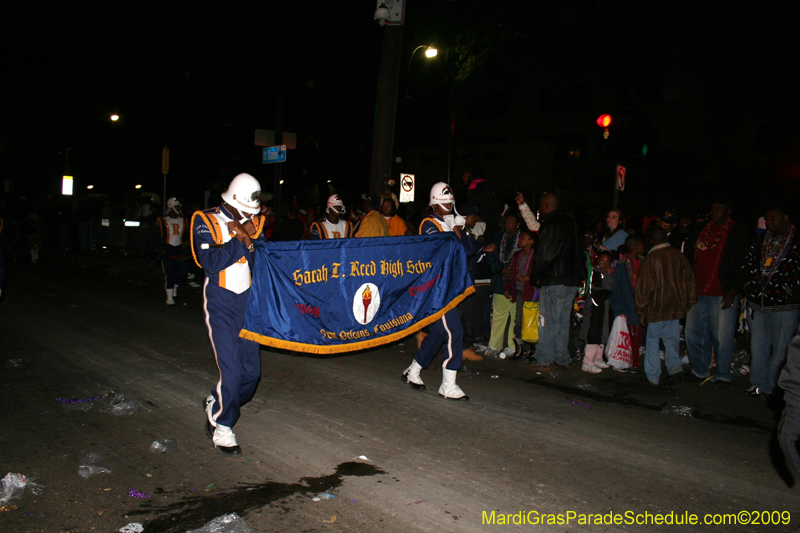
[0,0,800,214]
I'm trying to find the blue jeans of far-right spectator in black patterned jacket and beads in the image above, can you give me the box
[747,309,800,392]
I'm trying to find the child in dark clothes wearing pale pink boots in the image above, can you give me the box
[578,250,614,374]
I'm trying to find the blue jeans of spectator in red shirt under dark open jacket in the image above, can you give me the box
[686,295,739,383]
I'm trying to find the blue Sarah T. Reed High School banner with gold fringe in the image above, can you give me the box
[239,232,475,354]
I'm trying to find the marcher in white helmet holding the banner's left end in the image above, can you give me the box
[191,174,264,456]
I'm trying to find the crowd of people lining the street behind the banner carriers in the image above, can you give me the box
[0,173,800,396]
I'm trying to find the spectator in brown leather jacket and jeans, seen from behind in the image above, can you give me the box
[636,227,698,385]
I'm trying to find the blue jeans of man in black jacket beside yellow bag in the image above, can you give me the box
[536,285,578,365]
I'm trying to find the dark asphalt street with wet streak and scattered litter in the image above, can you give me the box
[0,250,800,533]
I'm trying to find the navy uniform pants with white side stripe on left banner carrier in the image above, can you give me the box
[203,278,261,427]
